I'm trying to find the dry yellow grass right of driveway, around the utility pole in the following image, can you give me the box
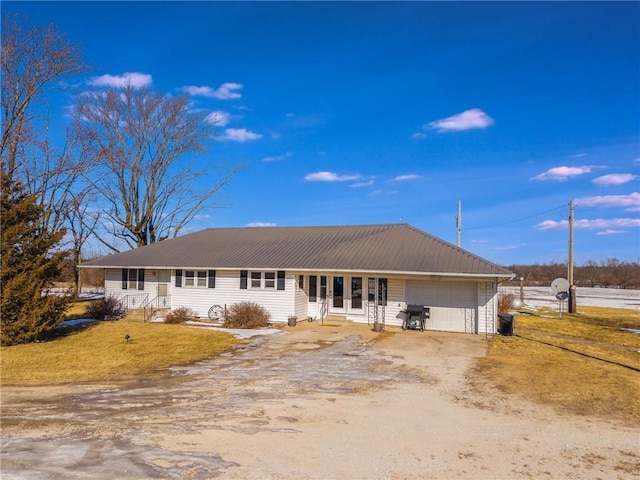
[471,307,640,424]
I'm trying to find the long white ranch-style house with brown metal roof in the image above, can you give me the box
[81,224,513,333]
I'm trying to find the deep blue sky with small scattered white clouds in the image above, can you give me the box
[2,2,640,265]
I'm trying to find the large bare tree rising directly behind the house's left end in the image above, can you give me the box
[74,86,236,251]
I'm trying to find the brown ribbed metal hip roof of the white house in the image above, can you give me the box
[81,224,513,277]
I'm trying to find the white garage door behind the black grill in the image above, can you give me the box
[405,280,477,333]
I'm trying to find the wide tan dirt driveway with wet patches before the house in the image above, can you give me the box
[0,323,640,480]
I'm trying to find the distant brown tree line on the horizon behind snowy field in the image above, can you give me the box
[505,258,640,288]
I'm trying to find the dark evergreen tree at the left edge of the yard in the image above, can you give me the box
[0,172,70,345]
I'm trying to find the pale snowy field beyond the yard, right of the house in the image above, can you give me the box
[499,286,640,311]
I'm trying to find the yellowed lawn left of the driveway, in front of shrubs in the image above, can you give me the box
[0,320,238,385]
